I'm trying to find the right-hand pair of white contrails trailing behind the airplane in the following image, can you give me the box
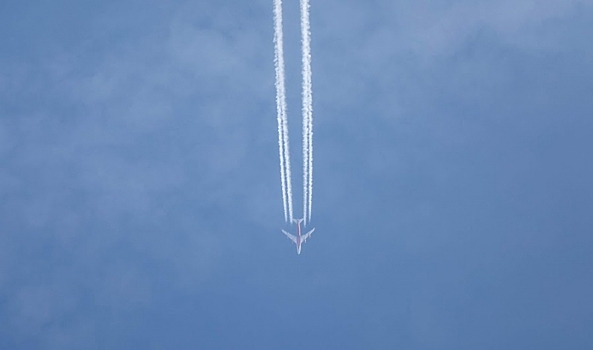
[300,0,313,224]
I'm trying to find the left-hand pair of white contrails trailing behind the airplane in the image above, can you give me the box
[274,0,293,222]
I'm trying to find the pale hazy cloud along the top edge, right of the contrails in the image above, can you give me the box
[312,0,593,113]
